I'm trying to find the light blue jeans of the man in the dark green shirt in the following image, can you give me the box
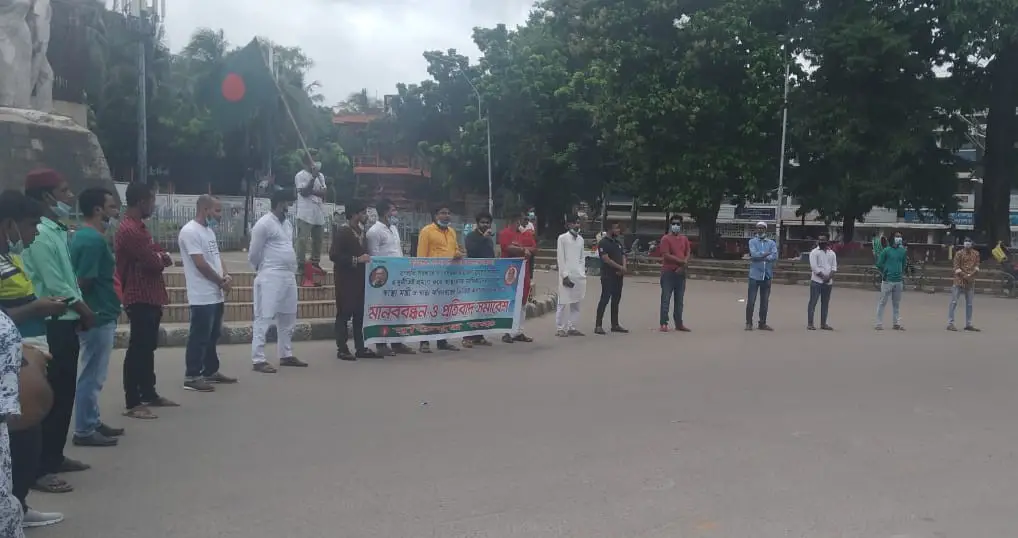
[74,321,117,437]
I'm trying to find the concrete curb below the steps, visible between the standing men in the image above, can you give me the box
[113,293,558,349]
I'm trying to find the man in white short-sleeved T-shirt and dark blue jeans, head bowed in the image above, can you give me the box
[177,195,237,392]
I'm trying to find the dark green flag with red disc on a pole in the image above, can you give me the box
[207,39,278,130]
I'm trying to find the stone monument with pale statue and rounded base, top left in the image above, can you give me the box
[0,0,113,192]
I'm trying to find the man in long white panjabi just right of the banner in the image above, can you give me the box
[555,215,586,336]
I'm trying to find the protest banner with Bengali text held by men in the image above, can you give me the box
[364,258,525,344]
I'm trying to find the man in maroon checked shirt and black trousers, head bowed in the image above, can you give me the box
[114,183,177,419]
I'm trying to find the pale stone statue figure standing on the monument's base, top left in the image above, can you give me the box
[0,0,53,112]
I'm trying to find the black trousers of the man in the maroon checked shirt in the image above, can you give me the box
[124,304,163,409]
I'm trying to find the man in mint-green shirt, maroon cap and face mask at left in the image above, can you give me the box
[22,169,96,492]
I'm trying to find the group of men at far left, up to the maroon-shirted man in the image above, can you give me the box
[0,169,177,536]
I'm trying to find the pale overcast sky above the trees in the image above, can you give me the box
[152,0,533,104]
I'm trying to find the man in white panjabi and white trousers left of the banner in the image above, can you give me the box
[247,191,307,374]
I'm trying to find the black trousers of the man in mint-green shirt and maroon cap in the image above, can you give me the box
[38,320,81,477]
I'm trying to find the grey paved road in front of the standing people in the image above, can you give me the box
[31,282,1018,538]
